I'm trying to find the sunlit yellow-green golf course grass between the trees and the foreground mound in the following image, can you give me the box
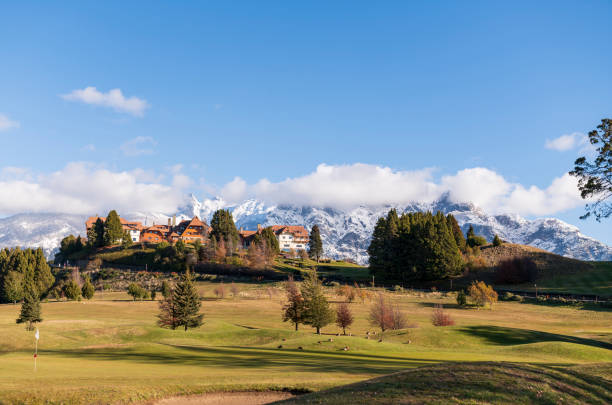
[0,283,612,403]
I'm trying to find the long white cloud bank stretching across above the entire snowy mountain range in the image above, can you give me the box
[0,162,584,216]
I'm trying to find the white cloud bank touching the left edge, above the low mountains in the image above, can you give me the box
[0,162,187,215]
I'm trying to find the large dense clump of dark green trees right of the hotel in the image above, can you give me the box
[368,210,463,282]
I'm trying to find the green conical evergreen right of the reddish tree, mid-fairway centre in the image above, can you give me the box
[302,271,336,335]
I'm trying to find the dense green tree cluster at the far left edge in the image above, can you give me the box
[0,247,55,303]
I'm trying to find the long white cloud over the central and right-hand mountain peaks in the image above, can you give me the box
[220,163,584,216]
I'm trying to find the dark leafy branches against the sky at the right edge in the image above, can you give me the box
[570,118,612,221]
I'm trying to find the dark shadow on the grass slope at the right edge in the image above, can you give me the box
[458,325,612,350]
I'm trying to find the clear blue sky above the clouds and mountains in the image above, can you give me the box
[0,1,612,244]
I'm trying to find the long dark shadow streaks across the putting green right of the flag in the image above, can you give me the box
[45,344,437,374]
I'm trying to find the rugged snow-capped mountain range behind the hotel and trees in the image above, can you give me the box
[0,195,612,263]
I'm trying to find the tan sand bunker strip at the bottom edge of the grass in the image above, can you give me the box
[153,391,293,405]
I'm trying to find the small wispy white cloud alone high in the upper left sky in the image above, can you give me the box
[61,86,149,117]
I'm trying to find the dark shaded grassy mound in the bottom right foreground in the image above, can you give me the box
[279,362,612,405]
